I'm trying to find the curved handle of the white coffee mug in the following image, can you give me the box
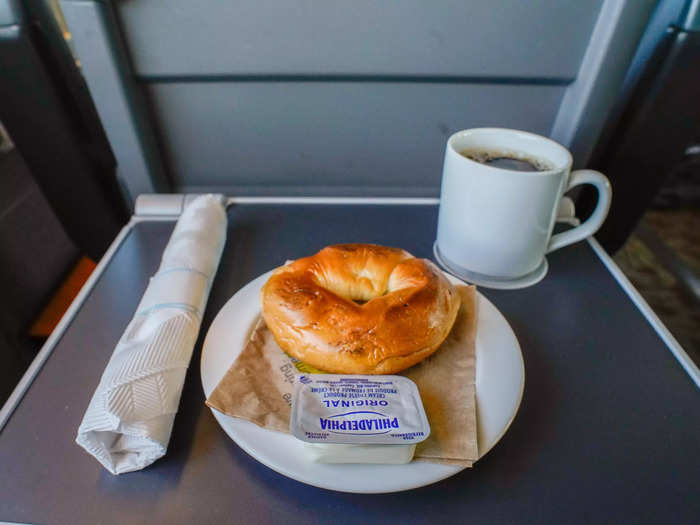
[547,170,612,253]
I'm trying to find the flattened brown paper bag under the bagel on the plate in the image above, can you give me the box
[207,286,478,467]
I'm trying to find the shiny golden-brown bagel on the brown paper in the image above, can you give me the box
[261,244,460,374]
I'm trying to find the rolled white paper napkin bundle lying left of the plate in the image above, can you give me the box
[76,195,226,474]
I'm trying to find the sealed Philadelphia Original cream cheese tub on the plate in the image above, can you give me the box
[290,374,430,463]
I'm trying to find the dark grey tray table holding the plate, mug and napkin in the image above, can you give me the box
[0,199,700,525]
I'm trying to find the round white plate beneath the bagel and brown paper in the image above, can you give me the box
[200,272,525,493]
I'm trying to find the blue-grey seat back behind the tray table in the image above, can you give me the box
[60,0,655,201]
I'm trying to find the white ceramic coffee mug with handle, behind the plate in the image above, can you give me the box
[435,128,612,288]
